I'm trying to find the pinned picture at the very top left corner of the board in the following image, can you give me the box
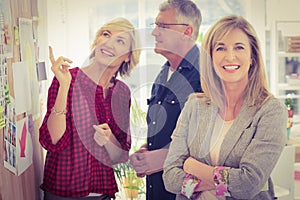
[0,0,13,58]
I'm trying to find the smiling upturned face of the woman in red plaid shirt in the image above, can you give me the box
[95,30,131,68]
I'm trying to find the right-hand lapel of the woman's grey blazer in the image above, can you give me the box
[219,103,256,166]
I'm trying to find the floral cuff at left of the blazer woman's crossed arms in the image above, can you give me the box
[181,174,201,199]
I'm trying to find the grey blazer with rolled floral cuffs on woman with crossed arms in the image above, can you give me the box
[163,95,287,200]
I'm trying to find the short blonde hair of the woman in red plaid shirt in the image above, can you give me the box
[90,17,141,77]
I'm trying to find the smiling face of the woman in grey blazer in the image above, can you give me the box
[212,28,251,85]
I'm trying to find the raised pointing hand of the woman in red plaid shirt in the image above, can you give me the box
[49,46,72,87]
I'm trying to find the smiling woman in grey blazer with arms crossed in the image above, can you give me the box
[163,15,288,200]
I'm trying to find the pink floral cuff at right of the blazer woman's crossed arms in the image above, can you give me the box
[214,166,230,196]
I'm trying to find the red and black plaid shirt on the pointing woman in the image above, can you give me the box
[39,68,131,197]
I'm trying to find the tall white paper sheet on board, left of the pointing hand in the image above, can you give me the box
[19,18,40,119]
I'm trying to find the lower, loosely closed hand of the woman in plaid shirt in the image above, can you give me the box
[93,123,112,147]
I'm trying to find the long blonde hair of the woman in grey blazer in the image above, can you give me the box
[200,15,273,108]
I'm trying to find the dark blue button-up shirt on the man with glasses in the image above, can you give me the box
[147,45,202,200]
